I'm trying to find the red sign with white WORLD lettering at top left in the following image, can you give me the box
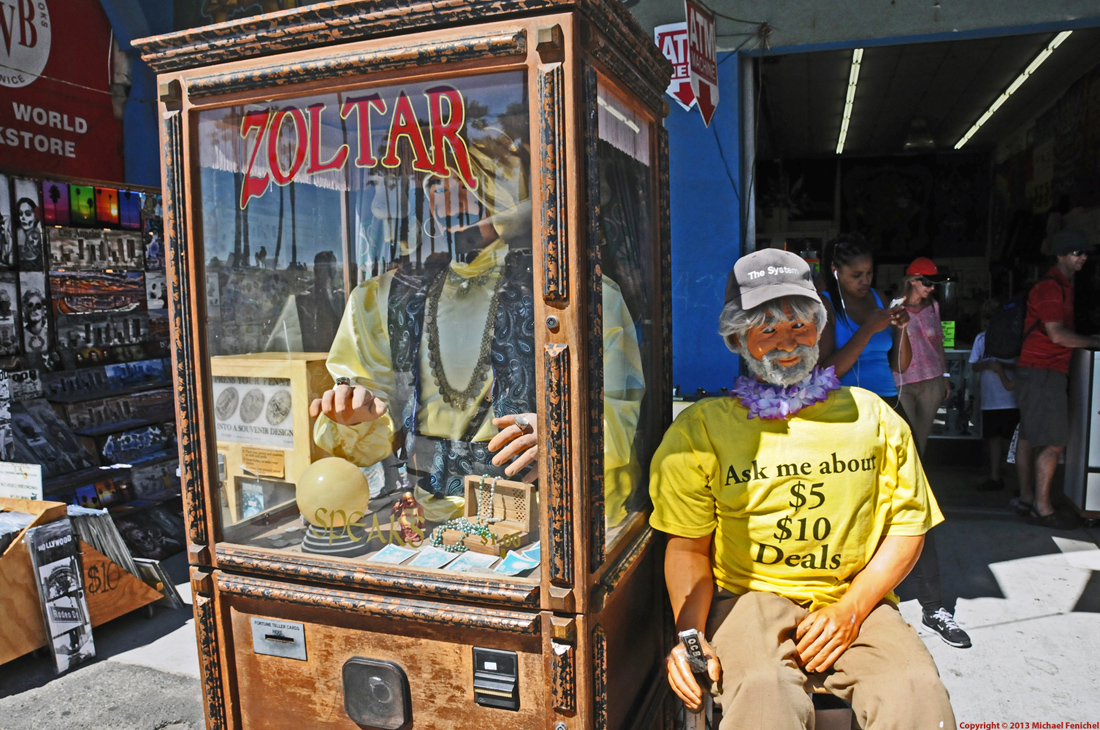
[0,0,124,180]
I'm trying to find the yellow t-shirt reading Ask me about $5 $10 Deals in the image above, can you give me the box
[649,387,944,610]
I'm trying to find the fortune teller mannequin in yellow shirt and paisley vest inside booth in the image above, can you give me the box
[310,150,644,522]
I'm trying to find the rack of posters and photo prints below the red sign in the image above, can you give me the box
[0,169,184,571]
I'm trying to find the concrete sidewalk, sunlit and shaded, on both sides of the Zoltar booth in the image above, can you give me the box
[0,452,1100,730]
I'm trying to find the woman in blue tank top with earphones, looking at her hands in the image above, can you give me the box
[820,236,912,408]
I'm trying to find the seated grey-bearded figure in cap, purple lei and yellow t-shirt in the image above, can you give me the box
[650,250,955,730]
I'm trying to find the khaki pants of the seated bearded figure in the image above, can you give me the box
[706,587,956,730]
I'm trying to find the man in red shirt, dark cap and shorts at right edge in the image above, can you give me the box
[1016,230,1100,529]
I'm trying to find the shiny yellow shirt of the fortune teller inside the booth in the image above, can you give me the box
[314,241,646,524]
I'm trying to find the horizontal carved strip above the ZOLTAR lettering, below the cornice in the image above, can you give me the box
[187,31,527,99]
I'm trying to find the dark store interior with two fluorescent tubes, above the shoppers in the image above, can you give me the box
[747,29,1100,349]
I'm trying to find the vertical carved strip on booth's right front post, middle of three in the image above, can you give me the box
[545,343,573,587]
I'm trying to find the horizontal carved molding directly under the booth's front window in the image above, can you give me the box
[216,543,539,608]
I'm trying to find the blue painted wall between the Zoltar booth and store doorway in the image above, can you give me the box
[664,54,741,396]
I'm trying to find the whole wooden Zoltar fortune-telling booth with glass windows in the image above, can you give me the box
[135,5,671,730]
